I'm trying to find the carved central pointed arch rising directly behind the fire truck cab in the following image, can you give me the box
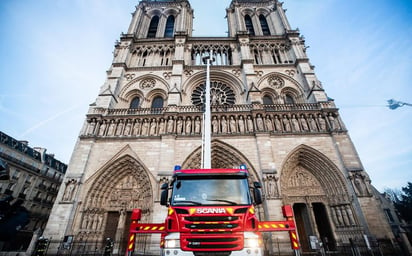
[182,140,260,181]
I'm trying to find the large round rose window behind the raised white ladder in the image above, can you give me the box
[192,81,235,107]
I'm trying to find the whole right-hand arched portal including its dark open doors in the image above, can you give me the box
[280,145,356,252]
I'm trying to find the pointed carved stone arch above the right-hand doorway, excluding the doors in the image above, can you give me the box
[280,144,349,203]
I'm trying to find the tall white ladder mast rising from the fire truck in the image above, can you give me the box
[202,53,212,169]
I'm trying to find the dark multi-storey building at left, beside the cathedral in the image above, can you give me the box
[0,132,67,251]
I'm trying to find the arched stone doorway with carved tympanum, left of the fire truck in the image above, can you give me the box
[77,155,153,255]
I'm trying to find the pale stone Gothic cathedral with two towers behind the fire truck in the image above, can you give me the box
[45,0,406,255]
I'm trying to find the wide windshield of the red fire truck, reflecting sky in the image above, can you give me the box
[172,177,251,206]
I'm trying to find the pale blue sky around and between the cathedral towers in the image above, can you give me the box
[0,0,412,192]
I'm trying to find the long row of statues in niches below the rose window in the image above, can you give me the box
[94,113,342,139]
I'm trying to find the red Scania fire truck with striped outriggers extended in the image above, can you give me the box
[126,166,299,256]
